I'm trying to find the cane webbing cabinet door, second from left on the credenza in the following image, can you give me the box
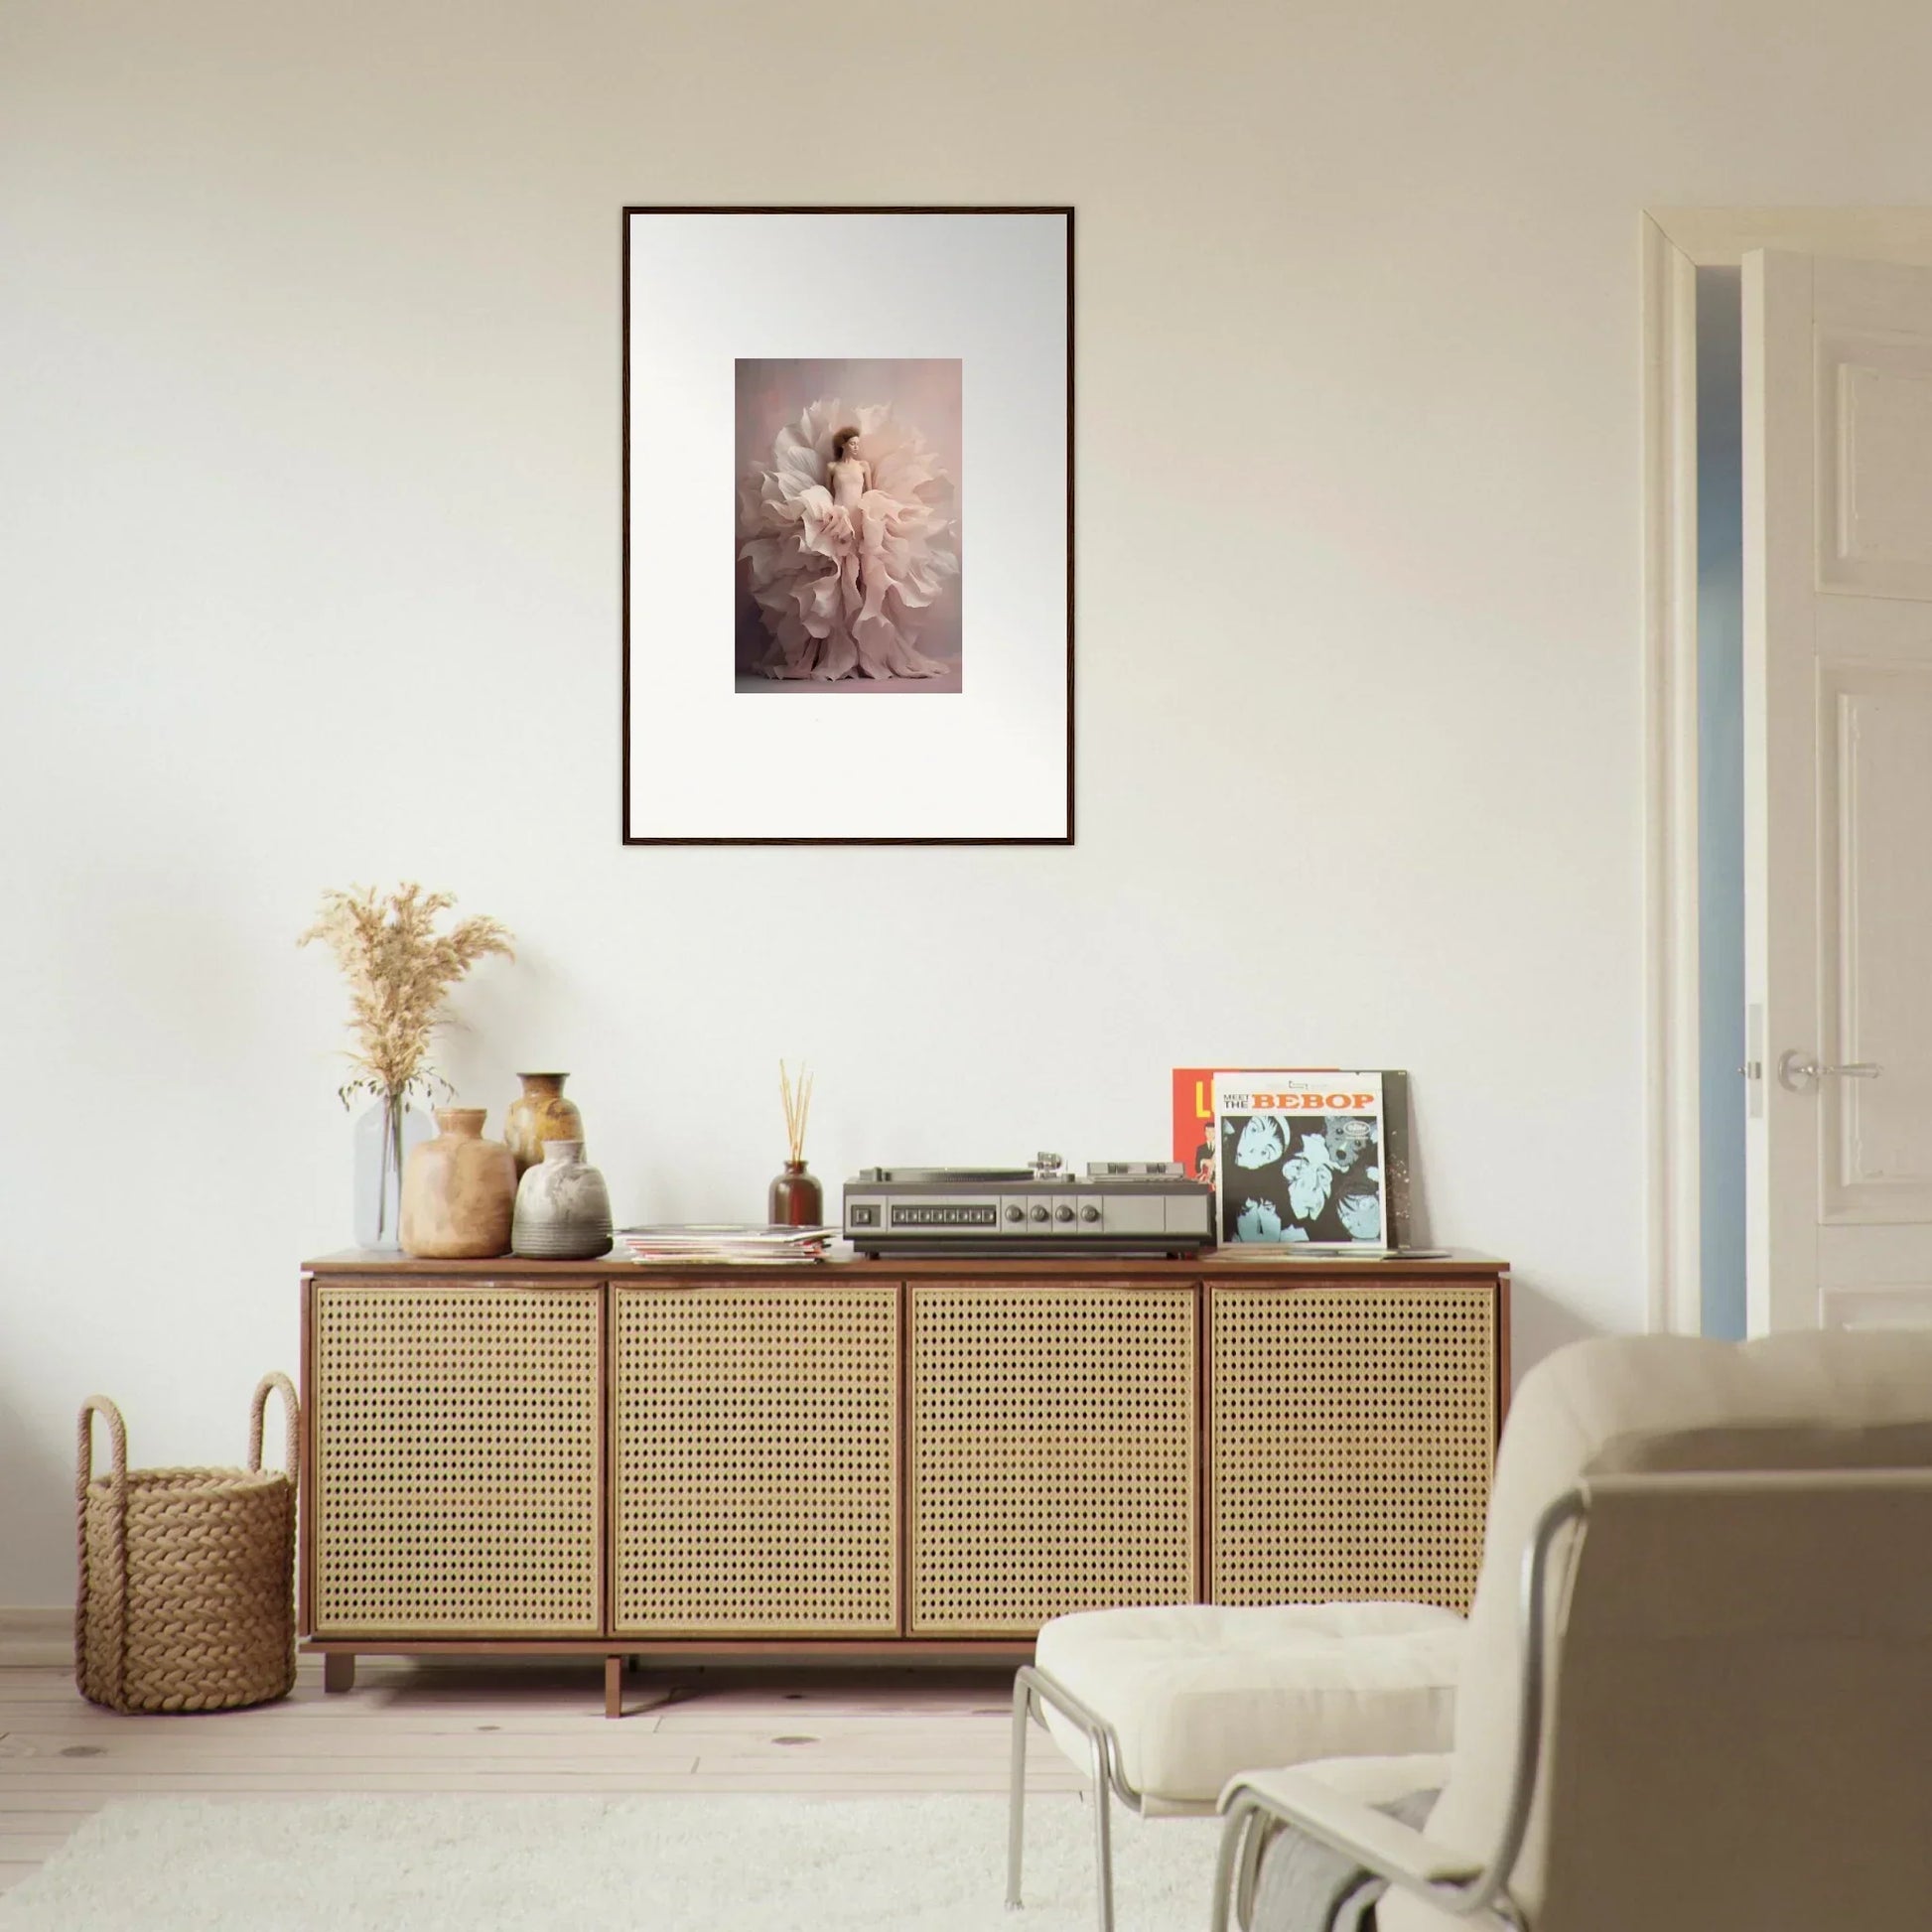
[611,1277,900,1636]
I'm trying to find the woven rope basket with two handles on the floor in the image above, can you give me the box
[73,1376,298,1710]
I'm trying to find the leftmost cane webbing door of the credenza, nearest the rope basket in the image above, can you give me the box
[304,1279,603,1636]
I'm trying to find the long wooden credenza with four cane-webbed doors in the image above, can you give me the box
[300,1254,1509,1708]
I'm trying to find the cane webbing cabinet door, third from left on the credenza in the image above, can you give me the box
[908,1281,1198,1636]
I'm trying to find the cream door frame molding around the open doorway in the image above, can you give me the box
[1640,207,1932,1335]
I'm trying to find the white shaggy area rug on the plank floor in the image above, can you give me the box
[0,1795,1217,1932]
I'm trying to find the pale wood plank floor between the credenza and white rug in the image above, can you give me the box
[0,1658,1080,1889]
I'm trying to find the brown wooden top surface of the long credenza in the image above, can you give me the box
[302,1248,1509,1289]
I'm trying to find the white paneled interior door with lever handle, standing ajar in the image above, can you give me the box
[1742,251,1932,1333]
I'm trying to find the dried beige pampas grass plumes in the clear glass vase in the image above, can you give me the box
[296,885,516,1107]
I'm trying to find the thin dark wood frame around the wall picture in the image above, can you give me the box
[619,203,1076,846]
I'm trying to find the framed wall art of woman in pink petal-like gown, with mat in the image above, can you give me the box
[624,207,1074,844]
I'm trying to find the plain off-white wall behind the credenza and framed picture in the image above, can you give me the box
[0,0,1932,1603]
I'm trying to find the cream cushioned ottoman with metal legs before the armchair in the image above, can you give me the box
[1007,1603,1464,1932]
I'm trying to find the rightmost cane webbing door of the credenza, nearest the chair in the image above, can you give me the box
[1207,1283,1497,1609]
